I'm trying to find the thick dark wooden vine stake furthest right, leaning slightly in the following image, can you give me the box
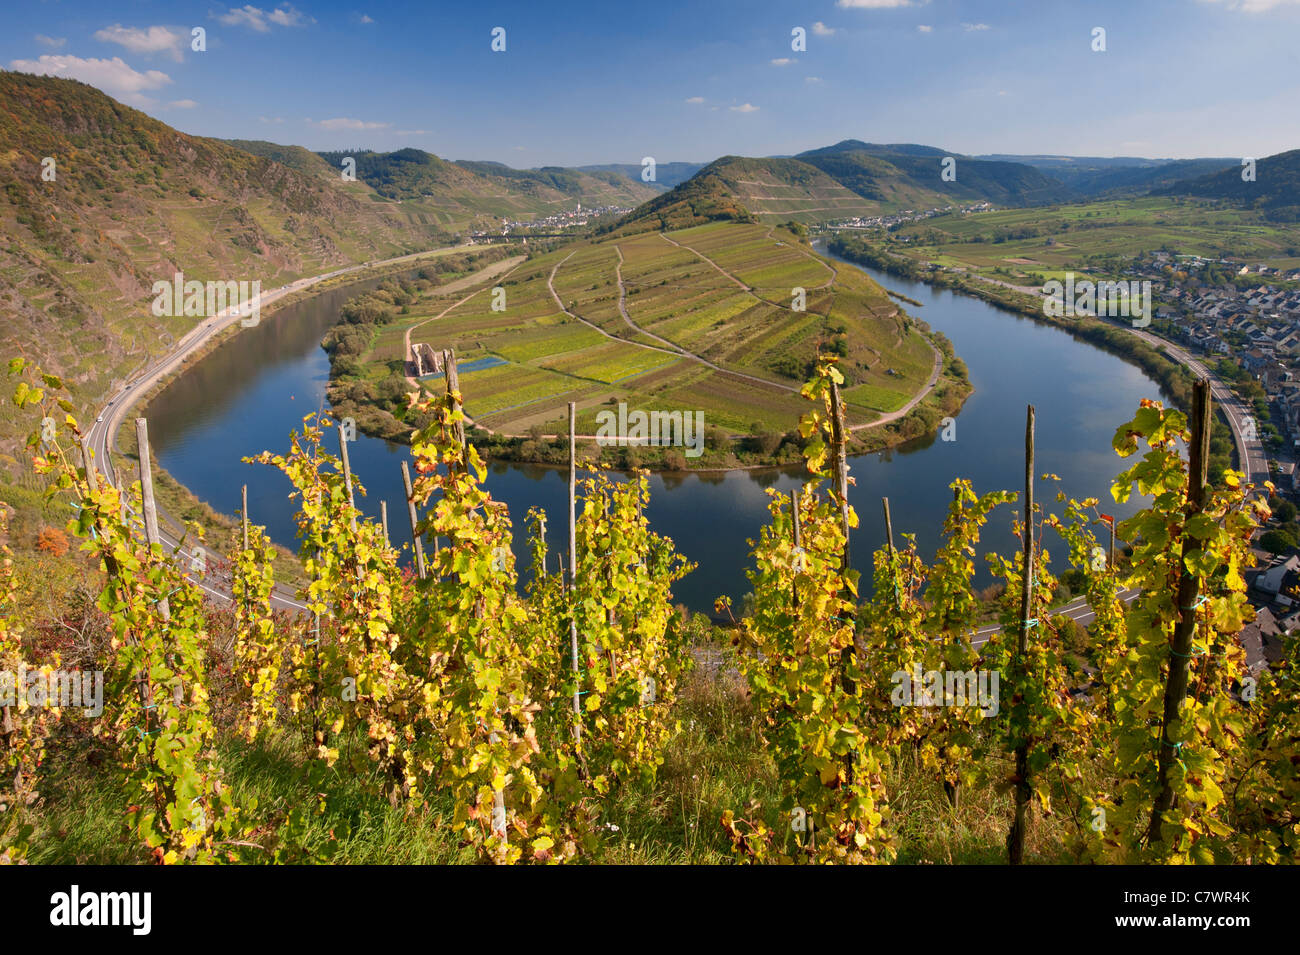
[1147,378,1212,845]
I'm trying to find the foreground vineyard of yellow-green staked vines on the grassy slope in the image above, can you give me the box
[0,358,1300,864]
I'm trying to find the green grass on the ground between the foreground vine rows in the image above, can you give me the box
[30,634,1071,865]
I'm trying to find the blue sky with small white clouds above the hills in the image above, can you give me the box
[0,0,1300,166]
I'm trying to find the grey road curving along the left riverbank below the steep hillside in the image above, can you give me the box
[86,246,460,611]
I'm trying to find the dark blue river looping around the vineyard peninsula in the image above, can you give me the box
[148,250,1165,612]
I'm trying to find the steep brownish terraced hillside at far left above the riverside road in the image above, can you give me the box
[0,71,446,466]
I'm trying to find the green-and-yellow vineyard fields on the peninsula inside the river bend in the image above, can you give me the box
[365,222,937,444]
